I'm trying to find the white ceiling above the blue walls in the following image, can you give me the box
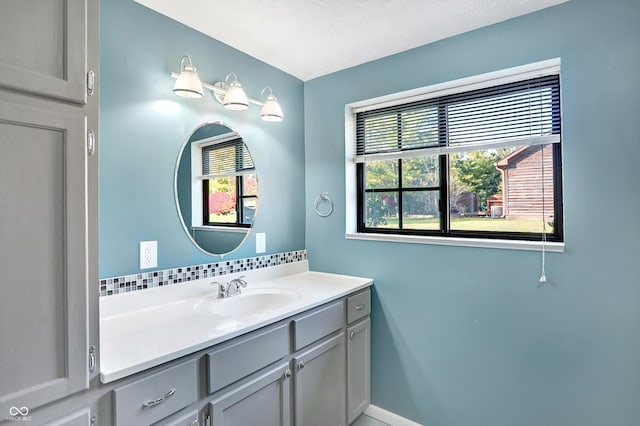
[135,0,568,81]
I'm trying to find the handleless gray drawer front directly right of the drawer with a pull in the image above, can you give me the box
[206,324,289,393]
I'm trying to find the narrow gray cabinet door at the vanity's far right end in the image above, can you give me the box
[347,318,371,424]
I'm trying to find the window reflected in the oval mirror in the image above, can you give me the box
[201,138,258,227]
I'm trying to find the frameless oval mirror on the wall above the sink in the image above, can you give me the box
[174,123,258,256]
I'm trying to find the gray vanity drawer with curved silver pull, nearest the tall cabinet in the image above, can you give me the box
[113,359,198,425]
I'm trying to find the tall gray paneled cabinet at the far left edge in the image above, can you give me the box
[0,0,99,424]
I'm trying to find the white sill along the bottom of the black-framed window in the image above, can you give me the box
[345,233,564,253]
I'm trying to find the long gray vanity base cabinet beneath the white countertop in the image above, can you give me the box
[98,290,370,426]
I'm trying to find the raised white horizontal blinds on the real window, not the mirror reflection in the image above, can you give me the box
[355,74,560,162]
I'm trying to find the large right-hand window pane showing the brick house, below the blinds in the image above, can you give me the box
[449,145,554,234]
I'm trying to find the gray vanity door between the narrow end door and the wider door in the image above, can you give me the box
[294,333,346,426]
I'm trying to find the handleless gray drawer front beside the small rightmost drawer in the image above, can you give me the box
[292,300,344,351]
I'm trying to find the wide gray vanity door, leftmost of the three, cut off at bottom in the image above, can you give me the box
[209,363,291,426]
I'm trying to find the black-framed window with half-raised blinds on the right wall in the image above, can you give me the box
[348,62,563,246]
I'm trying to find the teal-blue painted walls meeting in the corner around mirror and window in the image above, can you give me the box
[100,0,640,426]
